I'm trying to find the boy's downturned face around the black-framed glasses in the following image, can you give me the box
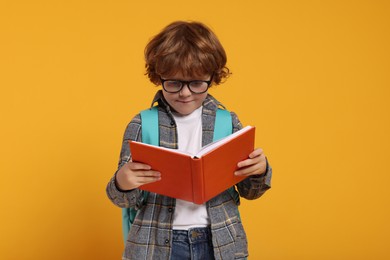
[162,73,211,115]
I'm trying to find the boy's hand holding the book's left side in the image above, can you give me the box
[116,161,161,190]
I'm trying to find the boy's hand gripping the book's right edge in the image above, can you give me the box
[234,148,267,176]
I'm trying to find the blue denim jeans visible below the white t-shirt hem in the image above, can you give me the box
[171,228,214,260]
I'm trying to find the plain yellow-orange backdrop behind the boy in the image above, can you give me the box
[0,0,390,260]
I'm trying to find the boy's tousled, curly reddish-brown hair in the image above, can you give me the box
[145,21,231,85]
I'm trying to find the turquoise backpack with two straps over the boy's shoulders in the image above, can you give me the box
[122,107,240,244]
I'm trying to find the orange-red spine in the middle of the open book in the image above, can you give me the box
[191,158,205,204]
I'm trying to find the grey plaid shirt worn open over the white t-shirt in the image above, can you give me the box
[107,91,272,260]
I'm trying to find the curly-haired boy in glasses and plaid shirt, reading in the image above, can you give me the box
[107,21,272,260]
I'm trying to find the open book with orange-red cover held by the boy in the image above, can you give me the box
[130,126,255,204]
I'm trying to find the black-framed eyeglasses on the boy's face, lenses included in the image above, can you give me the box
[160,78,212,94]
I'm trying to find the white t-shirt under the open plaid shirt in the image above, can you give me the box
[173,107,210,230]
